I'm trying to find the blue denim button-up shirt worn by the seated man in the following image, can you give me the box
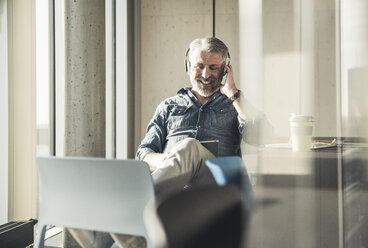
[136,88,245,159]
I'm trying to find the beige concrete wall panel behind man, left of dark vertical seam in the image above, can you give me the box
[140,0,212,142]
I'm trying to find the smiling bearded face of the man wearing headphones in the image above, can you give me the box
[189,49,224,97]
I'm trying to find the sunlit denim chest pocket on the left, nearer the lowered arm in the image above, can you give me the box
[167,106,191,130]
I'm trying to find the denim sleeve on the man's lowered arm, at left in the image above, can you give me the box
[136,102,167,160]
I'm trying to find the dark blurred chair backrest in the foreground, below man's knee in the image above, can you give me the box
[157,185,244,248]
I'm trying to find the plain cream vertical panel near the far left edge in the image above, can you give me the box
[8,0,37,220]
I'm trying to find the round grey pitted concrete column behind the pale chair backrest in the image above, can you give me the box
[64,1,105,157]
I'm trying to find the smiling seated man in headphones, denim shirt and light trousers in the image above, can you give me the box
[136,37,245,200]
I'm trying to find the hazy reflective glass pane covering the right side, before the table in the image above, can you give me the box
[239,0,368,247]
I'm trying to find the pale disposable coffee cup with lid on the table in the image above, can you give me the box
[289,115,313,152]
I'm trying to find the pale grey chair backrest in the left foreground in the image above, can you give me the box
[37,157,160,247]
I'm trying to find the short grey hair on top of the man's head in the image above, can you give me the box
[188,37,229,62]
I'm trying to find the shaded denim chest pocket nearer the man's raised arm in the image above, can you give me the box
[211,106,236,129]
